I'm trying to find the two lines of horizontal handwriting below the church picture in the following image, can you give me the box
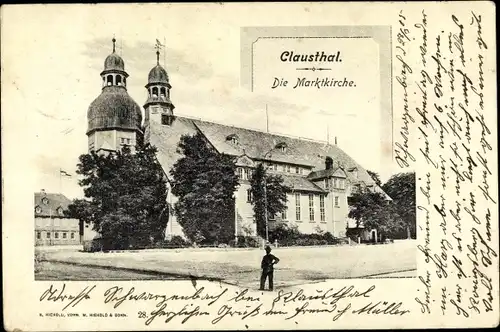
[36,284,410,325]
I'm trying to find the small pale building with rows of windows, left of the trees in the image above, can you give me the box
[34,190,81,246]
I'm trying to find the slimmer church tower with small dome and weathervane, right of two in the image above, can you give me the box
[144,47,175,140]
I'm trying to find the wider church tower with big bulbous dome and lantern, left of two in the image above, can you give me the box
[87,38,143,153]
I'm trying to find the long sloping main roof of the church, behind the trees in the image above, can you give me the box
[150,116,374,190]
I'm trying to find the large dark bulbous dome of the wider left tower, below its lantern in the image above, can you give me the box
[87,86,142,135]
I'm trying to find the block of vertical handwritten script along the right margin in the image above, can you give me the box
[395,10,498,318]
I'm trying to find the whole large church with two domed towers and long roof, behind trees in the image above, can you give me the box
[87,39,390,243]
